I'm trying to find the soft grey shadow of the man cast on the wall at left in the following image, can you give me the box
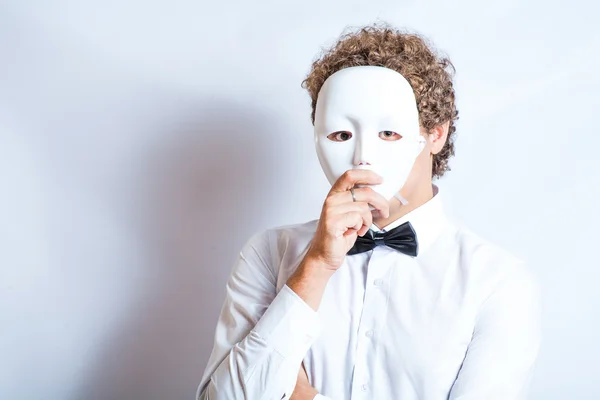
[72,99,277,400]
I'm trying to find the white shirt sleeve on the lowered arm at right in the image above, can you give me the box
[449,264,541,400]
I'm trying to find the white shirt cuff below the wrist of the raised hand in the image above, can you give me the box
[253,285,321,360]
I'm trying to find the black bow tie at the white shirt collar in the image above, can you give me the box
[347,221,419,257]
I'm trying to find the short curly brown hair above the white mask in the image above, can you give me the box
[301,23,458,178]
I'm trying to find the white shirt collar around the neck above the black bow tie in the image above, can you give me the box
[371,184,448,251]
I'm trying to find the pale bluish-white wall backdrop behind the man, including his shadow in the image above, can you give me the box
[0,0,600,400]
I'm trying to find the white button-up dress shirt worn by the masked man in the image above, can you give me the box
[196,185,540,400]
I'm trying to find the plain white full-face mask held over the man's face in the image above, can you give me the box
[315,66,425,203]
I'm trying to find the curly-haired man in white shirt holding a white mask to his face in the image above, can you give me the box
[197,26,540,400]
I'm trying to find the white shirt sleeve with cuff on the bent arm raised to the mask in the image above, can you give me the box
[196,230,321,400]
